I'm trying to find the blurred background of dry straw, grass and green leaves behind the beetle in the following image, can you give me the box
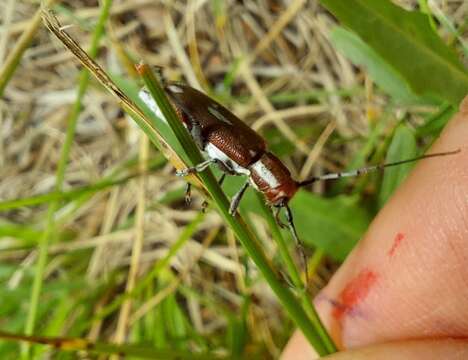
[0,0,468,359]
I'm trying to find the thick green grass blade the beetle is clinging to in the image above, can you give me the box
[137,64,336,355]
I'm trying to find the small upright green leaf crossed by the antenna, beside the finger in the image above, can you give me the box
[379,124,418,207]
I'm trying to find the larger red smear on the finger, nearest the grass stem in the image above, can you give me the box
[332,269,377,323]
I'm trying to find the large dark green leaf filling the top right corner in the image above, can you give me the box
[320,0,468,105]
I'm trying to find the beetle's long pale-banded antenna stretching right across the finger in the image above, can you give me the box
[298,149,461,187]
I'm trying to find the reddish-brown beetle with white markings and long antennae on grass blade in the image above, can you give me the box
[139,82,460,268]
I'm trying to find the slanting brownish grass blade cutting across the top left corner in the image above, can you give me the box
[0,0,55,97]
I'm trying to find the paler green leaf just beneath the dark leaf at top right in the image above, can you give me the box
[330,26,423,103]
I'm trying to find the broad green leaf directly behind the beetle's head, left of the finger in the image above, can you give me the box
[290,191,370,261]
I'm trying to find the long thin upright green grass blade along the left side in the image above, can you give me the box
[22,0,112,358]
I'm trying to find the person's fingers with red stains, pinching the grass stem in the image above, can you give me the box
[282,97,468,360]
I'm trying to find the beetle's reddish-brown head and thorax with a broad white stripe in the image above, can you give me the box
[249,152,298,205]
